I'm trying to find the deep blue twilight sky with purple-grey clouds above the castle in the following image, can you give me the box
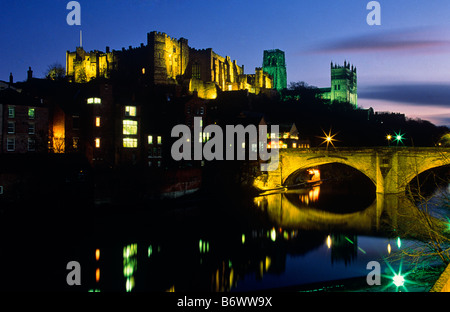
[0,0,450,125]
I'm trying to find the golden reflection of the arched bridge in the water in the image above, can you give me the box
[255,193,441,240]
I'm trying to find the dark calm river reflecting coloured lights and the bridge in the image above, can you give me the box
[1,167,449,292]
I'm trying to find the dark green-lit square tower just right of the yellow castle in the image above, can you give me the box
[263,49,287,91]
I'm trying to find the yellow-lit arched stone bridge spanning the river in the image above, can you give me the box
[254,147,450,194]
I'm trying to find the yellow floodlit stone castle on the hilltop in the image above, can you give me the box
[66,31,272,99]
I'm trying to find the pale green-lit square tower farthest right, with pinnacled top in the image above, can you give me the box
[331,61,358,108]
